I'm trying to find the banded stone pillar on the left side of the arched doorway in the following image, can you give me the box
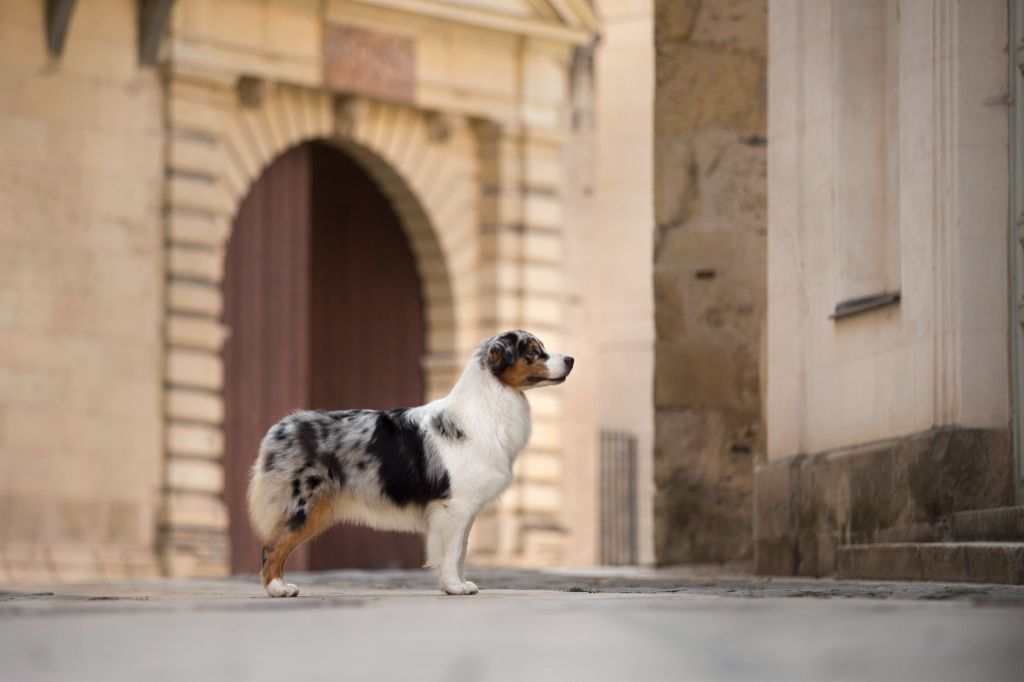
[158,70,233,576]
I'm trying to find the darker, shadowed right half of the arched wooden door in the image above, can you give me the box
[309,144,424,570]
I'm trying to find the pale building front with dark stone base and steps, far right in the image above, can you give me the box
[754,0,1024,582]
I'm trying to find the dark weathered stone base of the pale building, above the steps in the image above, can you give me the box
[754,427,1016,576]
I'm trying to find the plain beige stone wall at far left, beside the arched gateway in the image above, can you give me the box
[0,0,164,582]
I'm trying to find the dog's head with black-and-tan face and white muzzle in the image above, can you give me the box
[479,330,574,391]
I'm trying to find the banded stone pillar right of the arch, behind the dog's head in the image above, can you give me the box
[472,115,565,565]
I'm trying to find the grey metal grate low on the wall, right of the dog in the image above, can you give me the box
[600,429,637,565]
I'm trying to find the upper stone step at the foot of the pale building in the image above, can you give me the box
[853,506,1024,545]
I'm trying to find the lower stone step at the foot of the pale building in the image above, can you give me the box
[836,542,1024,585]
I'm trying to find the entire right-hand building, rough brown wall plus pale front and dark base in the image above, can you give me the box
[654,0,1024,582]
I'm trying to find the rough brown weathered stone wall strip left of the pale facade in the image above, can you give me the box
[654,0,767,564]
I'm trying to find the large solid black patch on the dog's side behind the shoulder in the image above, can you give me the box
[367,410,452,507]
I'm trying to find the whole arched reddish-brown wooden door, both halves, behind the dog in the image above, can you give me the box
[224,142,424,572]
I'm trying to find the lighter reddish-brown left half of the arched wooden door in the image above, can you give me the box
[224,146,311,572]
